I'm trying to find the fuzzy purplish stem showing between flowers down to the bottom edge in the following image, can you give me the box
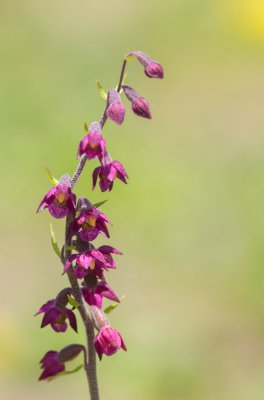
[65,60,127,400]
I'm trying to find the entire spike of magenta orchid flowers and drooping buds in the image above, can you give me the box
[36,51,164,380]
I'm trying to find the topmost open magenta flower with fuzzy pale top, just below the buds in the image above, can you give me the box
[78,122,106,160]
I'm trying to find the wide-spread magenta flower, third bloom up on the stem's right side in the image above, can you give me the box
[64,249,112,279]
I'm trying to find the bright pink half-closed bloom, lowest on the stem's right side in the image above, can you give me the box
[94,326,127,360]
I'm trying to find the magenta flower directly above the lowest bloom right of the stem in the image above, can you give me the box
[82,273,119,308]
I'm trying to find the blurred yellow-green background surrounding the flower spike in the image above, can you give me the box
[0,0,264,400]
